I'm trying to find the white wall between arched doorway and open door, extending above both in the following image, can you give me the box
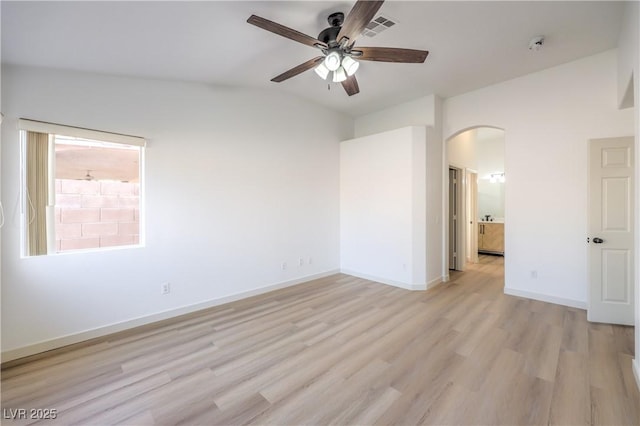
[444,50,634,307]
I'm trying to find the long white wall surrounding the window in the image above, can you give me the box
[2,67,353,360]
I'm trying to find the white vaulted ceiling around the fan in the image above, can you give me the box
[0,0,624,116]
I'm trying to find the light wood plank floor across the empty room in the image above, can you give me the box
[2,256,640,425]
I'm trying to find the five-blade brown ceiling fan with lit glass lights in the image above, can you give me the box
[247,0,429,96]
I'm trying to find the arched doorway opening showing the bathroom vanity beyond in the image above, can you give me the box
[446,126,506,271]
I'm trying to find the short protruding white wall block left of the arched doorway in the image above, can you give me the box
[340,127,427,289]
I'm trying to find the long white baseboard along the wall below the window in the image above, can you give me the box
[1,270,340,363]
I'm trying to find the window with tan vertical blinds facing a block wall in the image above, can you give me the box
[20,120,145,256]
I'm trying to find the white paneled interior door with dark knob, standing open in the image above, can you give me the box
[587,137,634,325]
